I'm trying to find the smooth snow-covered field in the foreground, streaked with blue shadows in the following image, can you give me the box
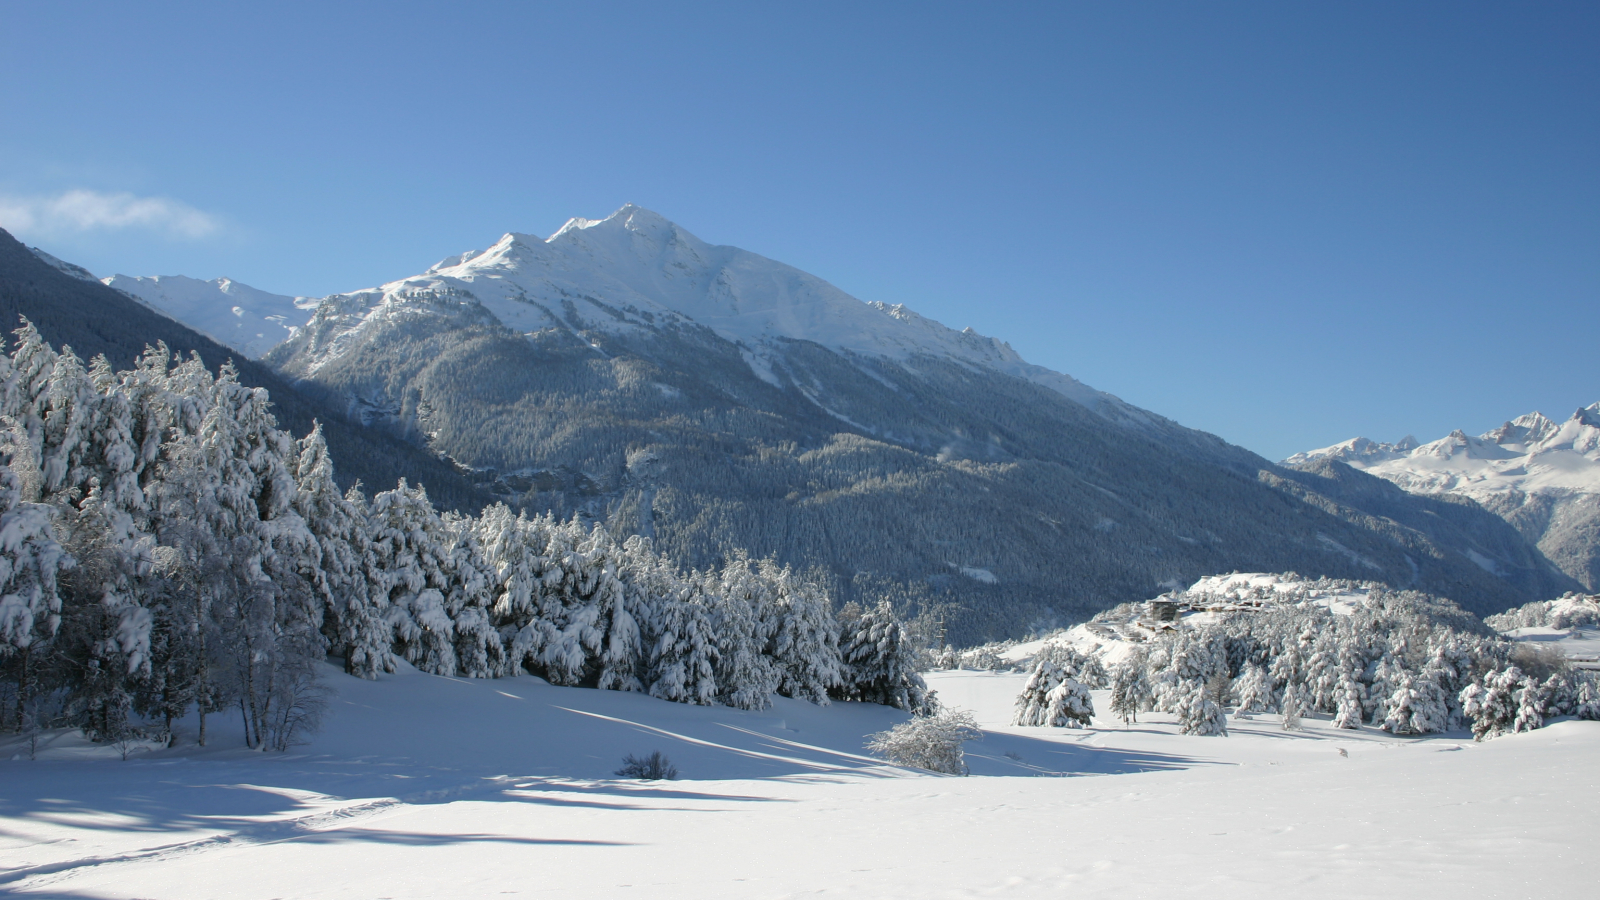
[0,671,1600,898]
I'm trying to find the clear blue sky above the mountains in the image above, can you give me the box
[0,0,1600,458]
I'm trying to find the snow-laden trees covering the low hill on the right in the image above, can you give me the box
[1014,580,1600,740]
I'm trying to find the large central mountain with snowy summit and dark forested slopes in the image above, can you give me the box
[15,205,1578,644]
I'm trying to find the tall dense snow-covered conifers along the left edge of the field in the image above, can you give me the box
[0,320,933,749]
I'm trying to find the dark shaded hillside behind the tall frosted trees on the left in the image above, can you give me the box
[0,224,485,511]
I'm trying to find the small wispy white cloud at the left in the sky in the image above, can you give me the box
[0,189,221,239]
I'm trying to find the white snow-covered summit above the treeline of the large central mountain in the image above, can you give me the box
[312,203,1154,421]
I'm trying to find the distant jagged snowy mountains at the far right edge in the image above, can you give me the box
[1285,404,1600,591]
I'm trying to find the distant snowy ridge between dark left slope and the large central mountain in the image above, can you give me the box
[101,275,322,359]
